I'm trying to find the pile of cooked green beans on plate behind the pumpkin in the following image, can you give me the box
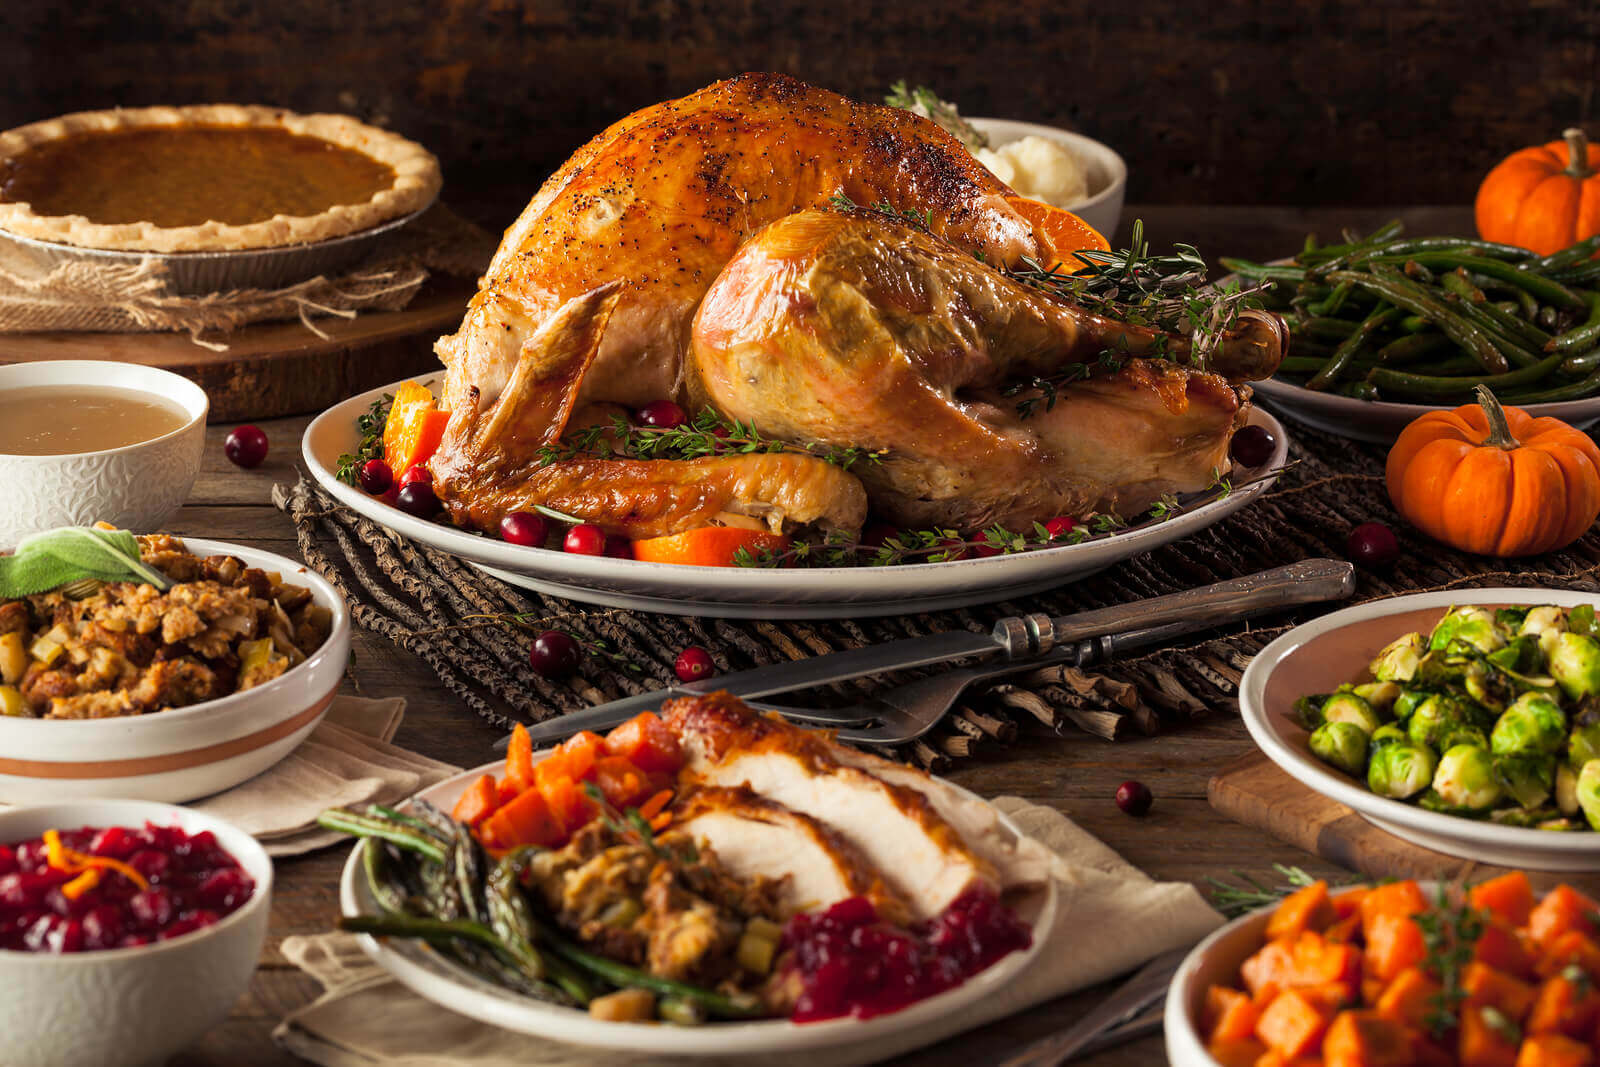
[1221,222,1600,405]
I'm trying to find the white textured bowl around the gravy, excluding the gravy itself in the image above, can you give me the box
[0,360,208,550]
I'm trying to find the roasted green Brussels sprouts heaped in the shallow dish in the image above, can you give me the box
[1294,605,1600,830]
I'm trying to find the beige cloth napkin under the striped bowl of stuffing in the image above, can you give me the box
[189,696,461,856]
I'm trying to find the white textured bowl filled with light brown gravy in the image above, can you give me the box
[0,360,208,552]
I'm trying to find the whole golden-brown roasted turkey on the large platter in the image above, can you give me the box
[432,74,1286,537]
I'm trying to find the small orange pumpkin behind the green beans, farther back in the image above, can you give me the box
[1474,130,1600,256]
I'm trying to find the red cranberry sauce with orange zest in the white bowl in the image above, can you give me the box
[0,822,256,953]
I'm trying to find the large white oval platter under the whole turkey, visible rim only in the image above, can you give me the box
[302,382,1288,619]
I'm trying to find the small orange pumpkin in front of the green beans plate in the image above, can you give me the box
[1386,386,1600,557]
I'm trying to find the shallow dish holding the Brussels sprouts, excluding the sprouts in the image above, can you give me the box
[1240,589,1600,870]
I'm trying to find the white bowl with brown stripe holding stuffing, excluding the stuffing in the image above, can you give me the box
[0,537,350,803]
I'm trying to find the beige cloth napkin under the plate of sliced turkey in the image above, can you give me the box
[272,797,1222,1067]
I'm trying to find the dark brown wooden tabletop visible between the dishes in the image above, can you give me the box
[152,206,1470,1067]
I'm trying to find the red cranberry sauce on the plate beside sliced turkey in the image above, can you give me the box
[784,888,1034,1022]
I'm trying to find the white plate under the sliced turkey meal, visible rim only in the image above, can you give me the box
[339,763,1058,1064]
